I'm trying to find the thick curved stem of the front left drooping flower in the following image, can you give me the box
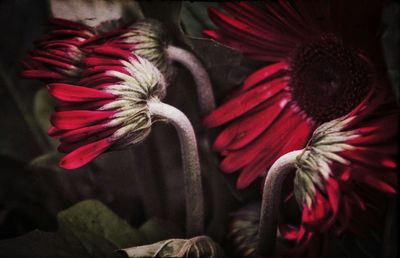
[148,101,204,237]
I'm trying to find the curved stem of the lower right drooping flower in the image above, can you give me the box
[257,150,303,258]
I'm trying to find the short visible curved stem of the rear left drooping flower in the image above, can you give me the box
[167,45,215,114]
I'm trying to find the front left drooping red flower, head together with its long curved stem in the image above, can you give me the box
[42,45,204,235]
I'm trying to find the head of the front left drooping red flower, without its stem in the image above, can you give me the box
[48,46,165,169]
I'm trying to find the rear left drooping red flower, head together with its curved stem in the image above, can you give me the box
[21,18,215,113]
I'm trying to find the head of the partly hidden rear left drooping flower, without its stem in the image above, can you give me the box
[22,18,167,82]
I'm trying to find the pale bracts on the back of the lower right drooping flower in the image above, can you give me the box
[294,117,359,208]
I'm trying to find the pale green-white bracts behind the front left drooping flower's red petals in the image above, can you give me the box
[100,56,166,148]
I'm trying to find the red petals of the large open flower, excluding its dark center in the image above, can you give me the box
[204,0,390,189]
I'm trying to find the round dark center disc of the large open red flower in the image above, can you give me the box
[289,37,373,123]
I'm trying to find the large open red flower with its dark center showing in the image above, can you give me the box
[204,0,386,189]
